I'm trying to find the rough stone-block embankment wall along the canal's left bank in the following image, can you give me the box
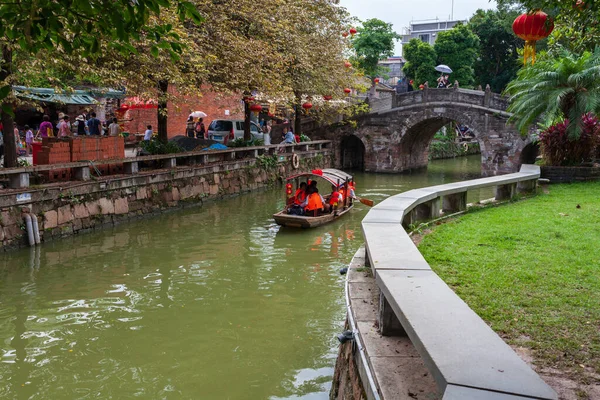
[0,150,331,250]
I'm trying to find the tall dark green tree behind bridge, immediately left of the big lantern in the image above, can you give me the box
[467,10,523,93]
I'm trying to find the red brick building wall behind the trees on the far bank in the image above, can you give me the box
[124,88,244,137]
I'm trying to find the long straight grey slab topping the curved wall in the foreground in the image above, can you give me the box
[376,270,557,399]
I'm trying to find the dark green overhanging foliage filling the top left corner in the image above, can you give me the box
[0,0,202,167]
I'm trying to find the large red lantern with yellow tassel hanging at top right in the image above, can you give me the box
[513,10,554,65]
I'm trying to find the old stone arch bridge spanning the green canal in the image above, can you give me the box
[325,88,531,176]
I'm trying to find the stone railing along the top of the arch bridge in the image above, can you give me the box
[392,88,509,111]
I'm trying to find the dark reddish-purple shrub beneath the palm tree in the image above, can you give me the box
[540,113,600,166]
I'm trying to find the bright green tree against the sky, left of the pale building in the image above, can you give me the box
[352,18,400,85]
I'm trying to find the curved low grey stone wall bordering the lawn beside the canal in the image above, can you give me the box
[362,163,557,400]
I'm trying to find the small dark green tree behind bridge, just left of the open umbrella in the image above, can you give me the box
[402,39,437,86]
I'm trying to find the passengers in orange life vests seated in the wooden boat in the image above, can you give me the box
[287,180,356,217]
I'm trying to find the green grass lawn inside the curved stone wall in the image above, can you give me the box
[419,183,600,373]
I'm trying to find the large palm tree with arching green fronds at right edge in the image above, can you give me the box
[505,48,600,140]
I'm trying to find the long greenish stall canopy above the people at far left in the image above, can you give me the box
[13,86,125,105]
